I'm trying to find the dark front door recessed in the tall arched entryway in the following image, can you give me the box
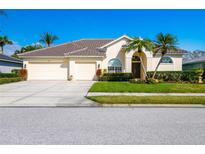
[132,55,141,78]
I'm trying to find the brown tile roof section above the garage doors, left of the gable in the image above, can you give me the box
[19,39,113,57]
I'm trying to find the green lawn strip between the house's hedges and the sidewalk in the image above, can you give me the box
[89,82,205,93]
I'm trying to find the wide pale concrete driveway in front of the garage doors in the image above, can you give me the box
[0,81,95,106]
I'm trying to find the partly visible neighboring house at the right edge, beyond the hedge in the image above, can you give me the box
[183,56,205,70]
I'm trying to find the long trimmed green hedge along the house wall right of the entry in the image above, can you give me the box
[147,71,198,83]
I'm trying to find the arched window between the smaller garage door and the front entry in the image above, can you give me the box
[108,58,122,73]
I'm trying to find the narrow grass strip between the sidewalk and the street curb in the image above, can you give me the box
[88,96,205,105]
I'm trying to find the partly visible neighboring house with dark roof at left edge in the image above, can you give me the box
[0,53,23,73]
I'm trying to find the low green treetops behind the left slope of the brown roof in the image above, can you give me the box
[12,44,43,58]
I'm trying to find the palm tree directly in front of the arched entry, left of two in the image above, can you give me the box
[124,37,154,77]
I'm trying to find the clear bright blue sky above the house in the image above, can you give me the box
[0,9,205,55]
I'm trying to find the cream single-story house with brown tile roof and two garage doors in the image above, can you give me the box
[19,35,184,80]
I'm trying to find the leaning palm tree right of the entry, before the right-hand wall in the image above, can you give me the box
[152,33,177,79]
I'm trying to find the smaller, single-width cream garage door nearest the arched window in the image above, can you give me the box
[75,62,96,80]
